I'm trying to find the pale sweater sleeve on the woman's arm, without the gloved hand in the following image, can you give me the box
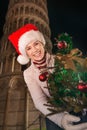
[24,72,64,127]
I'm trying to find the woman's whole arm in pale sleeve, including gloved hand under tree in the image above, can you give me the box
[24,70,87,130]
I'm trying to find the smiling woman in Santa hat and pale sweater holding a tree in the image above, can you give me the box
[8,24,87,130]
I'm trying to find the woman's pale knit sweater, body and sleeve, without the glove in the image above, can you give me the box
[23,54,64,127]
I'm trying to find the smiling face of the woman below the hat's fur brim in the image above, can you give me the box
[25,41,45,61]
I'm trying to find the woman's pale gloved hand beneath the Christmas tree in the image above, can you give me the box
[61,113,87,130]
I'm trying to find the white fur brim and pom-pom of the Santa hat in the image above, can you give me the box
[17,30,45,65]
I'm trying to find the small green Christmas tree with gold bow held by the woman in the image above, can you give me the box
[47,33,87,113]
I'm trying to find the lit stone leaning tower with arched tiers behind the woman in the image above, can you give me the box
[0,0,52,130]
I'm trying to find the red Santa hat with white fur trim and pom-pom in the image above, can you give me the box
[8,24,45,65]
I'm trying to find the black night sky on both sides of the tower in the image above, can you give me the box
[0,0,87,53]
